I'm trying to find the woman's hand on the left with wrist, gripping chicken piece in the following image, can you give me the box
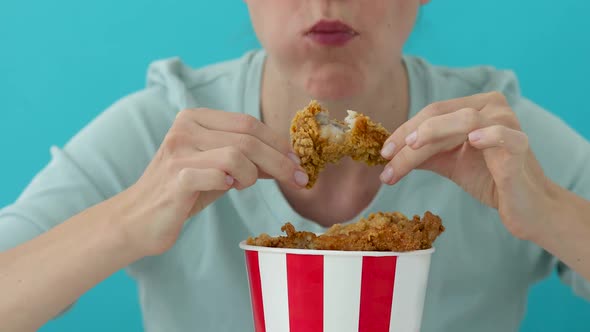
[115,109,308,256]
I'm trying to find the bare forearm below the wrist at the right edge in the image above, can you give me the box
[533,184,590,280]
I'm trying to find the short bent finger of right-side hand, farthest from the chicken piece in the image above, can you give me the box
[469,125,529,154]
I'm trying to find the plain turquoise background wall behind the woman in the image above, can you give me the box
[0,0,590,332]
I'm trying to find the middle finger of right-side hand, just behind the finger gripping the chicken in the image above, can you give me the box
[405,108,486,149]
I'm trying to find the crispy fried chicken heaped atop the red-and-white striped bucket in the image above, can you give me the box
[247,212,445,252]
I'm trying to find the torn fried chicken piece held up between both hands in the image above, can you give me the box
[290,101,390,189]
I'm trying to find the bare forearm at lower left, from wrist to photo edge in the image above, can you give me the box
[0,197,140,331]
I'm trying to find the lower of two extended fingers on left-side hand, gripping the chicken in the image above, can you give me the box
[197,130,309,187]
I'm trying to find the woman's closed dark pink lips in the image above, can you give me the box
[305,20,358,46]
